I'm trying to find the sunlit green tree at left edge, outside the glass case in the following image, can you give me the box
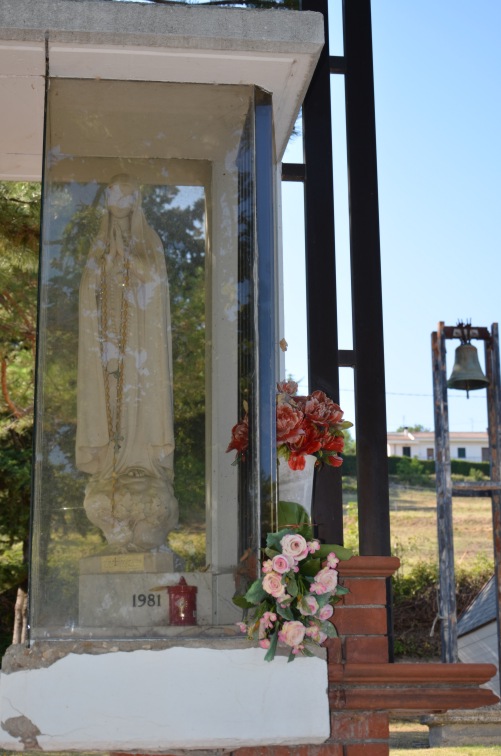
[0,183,40,589]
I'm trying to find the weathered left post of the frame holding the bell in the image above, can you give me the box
[431,323,458,663]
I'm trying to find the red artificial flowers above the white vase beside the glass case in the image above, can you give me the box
[226,381,352,470]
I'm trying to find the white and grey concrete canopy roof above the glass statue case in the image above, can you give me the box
[0,0,324,181]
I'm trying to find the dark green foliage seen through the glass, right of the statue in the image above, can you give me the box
[143,187,206,522]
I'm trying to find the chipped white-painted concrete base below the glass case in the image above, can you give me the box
[0,647,330,753]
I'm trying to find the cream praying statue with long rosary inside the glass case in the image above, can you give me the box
[76,174,178,551]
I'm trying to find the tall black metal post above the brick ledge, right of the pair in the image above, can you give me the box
[343,0,391,556]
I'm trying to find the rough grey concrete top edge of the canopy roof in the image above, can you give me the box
[0,0,324,53]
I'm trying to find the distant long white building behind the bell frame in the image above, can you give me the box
[387,430,489,462]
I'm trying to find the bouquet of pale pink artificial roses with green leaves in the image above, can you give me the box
[233,502,352,661]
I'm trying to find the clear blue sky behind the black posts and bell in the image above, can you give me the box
[284,0,501,431]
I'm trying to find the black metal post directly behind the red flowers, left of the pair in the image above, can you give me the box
[302,0,343,543]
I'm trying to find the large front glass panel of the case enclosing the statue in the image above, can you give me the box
[31,80,274,638]
